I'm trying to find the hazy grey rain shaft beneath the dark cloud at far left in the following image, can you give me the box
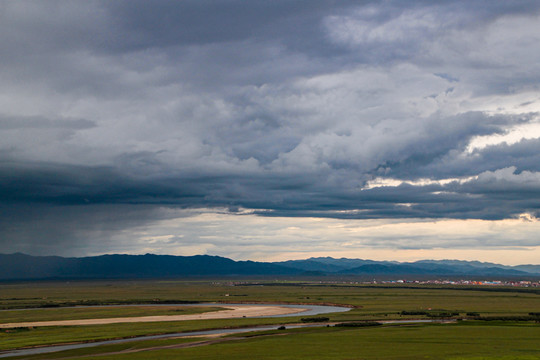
[0,203,186,256]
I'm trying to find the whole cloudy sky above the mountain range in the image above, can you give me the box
[0,0,540,264]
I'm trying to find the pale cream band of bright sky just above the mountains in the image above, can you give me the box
[94,211,540,265]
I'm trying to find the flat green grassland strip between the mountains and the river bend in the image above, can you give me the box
[0,281,540,314]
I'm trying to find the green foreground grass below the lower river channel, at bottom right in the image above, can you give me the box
[5,322,540,360]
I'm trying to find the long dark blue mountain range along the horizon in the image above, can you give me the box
[0,253,540,280]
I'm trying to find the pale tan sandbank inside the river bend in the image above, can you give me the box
[0,305,306,329]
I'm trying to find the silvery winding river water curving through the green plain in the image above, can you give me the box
[0,303,351,358]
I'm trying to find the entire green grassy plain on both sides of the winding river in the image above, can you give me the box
[0,281,540,359]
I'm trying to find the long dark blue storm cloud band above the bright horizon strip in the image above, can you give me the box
[0,150,540,224]
